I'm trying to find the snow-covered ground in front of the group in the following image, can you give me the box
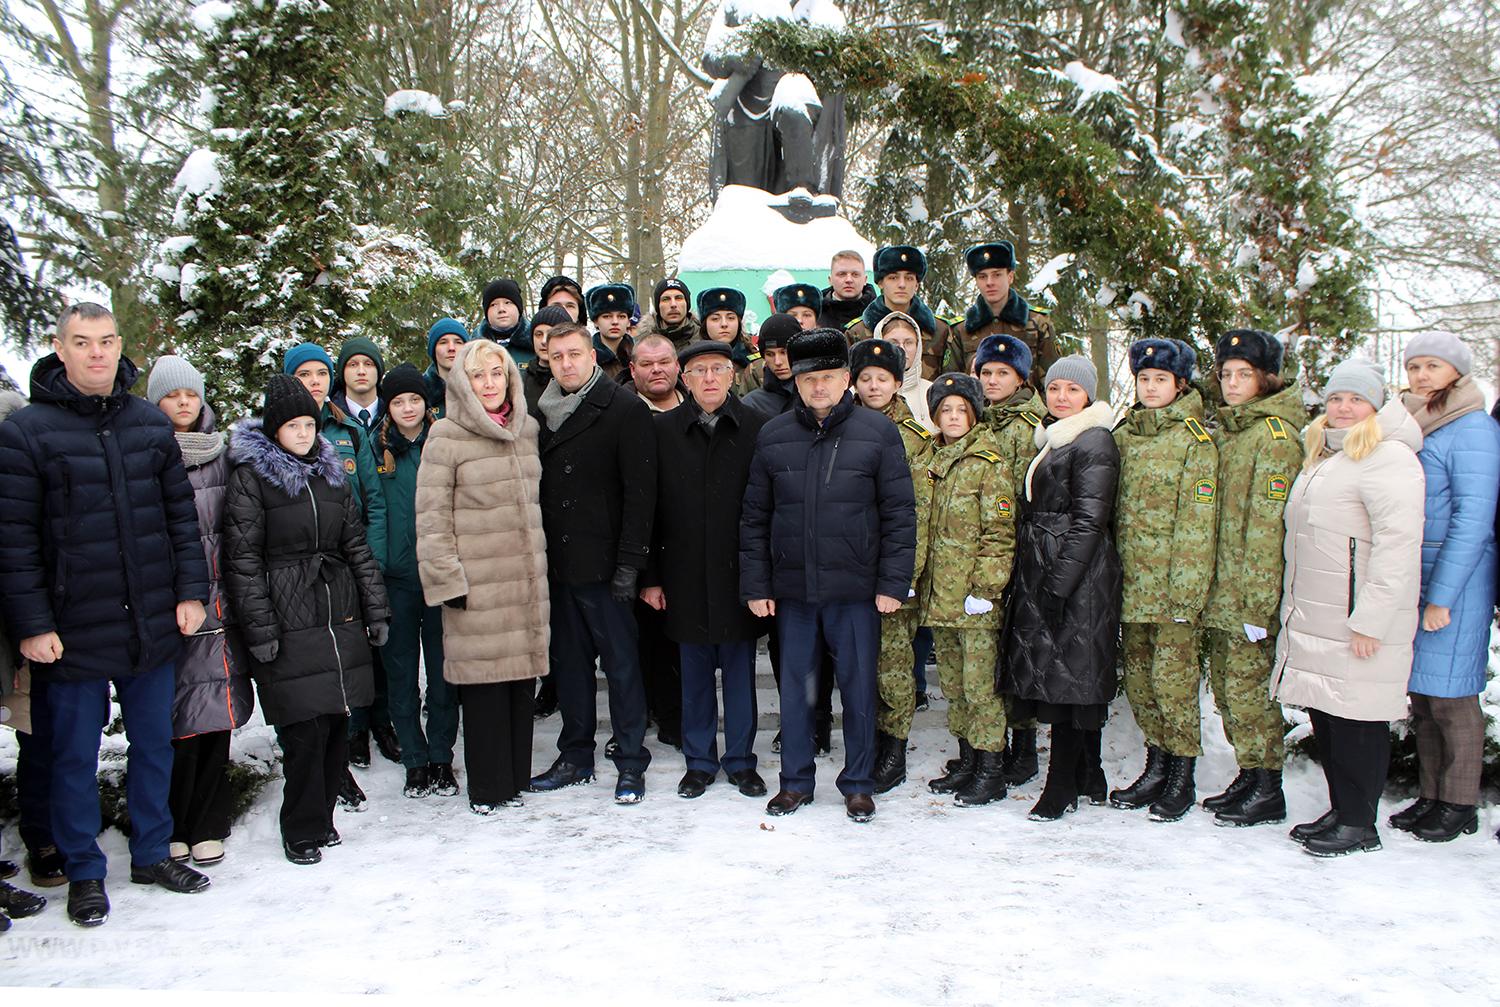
[0,657,1500,1004]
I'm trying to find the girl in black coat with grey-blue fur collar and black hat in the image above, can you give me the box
[224,374,390,863]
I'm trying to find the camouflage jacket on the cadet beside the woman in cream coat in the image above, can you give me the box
[1203,384,1308,633]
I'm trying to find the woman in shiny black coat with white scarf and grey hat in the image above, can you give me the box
[998,356,1121,821]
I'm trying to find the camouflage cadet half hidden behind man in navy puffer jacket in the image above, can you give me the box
[849,339,933,794]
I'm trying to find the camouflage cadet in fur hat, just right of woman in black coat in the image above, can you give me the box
[1110,339,1218,821]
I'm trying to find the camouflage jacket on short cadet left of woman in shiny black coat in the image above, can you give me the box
[917,423,1016,630]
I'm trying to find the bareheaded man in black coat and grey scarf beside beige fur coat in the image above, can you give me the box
[531,324,657,804]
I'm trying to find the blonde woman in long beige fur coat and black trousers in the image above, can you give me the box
[417,339,549,815]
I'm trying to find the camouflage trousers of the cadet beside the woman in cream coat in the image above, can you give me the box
[1205,629,1287,770]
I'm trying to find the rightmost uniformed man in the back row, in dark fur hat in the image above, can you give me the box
[948,242,1062,387]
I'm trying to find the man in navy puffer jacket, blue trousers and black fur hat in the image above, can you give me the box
[740,329,917,821]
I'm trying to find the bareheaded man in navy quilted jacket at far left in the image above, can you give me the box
[0,303,209,926]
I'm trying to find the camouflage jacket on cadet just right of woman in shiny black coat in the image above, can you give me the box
[1115,389,1218,623]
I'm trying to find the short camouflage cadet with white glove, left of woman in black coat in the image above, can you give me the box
[917,372,1016,807]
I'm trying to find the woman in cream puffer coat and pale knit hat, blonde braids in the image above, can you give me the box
[1271,359,1424,857]
